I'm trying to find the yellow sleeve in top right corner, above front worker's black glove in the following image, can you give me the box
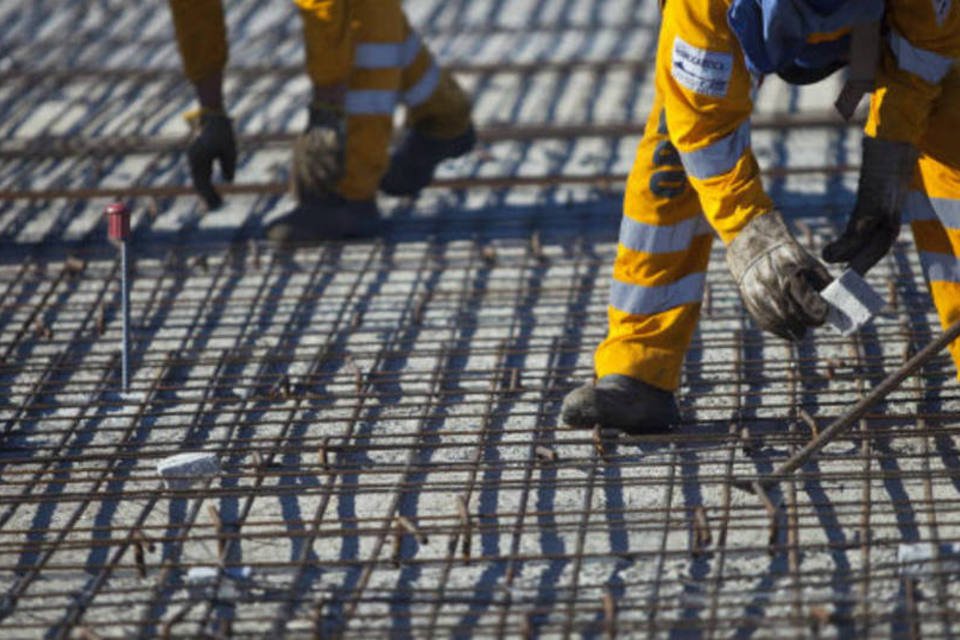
[866,0,960,144]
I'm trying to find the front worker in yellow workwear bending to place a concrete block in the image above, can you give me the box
[562,0,960,434]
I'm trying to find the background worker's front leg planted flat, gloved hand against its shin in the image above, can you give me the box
[267,0,407,244]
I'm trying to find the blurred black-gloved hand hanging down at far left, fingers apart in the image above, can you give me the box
[187,109,237,209]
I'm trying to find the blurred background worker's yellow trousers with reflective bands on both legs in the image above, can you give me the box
[294,0,470,200]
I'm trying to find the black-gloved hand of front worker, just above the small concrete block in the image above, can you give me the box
[823,137,917,275]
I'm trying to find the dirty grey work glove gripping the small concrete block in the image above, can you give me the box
[727,211,830,340]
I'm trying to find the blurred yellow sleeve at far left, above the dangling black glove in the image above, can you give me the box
[169,0,227,82]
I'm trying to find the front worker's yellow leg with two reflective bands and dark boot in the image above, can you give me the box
[564,95,713,431]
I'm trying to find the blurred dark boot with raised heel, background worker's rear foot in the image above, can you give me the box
[380,125,477,196]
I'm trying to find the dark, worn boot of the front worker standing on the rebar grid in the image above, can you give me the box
[560,374,680,435]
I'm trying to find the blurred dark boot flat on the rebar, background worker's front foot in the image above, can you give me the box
[266,193,380,247]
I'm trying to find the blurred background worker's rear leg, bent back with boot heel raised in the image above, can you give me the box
[380,12,476,196]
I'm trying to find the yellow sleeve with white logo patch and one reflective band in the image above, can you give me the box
[656,1,773,243]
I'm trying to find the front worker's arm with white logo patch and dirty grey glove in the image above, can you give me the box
[656,1,829,339]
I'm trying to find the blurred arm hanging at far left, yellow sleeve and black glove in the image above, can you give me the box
[169,0,237,209]
